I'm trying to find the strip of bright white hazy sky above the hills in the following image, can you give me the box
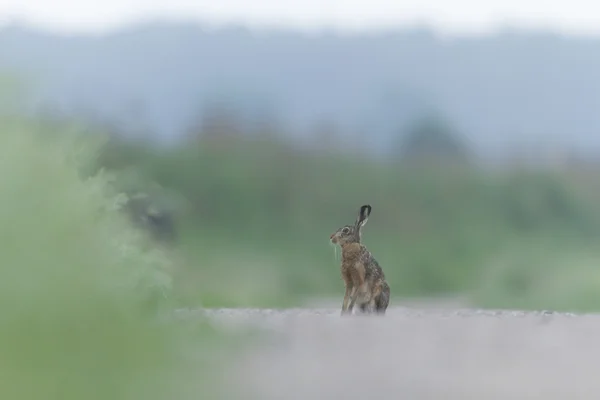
[0,0,600,35]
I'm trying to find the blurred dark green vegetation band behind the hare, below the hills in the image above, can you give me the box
[88,108,600,309]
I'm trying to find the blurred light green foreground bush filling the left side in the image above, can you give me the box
[0,89,248,400]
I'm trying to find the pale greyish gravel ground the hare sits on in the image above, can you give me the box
[176,305,600,400]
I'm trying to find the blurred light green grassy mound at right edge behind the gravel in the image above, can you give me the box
[470,237,600,312]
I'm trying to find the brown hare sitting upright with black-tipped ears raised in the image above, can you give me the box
[330,204,390,315]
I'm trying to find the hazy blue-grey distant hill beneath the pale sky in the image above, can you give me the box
[0,23,600,158]
